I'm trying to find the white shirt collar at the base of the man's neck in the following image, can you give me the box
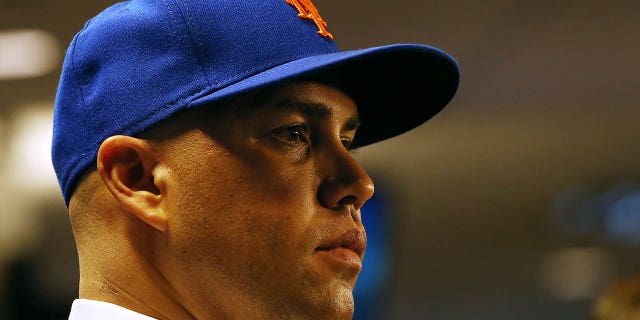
[69,299,156,320]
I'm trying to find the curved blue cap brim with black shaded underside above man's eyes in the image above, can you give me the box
[190,44,459,147]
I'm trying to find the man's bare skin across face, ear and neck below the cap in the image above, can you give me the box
[70,82,373,319]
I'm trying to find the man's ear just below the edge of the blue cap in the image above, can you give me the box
[97,135,168,232]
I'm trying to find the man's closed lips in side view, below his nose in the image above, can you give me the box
[316,229,367,269]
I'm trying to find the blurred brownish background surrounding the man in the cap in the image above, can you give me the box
[0,0,640,320]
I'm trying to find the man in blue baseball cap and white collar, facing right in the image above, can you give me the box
[52,0,458,320]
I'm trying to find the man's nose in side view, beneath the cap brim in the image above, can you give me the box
[318,147,374,214]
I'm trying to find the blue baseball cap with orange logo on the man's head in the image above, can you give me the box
[52,0,459,205]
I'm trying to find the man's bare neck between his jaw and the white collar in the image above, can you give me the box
[76,211,195,320]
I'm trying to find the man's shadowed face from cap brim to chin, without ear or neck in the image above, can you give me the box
[156,82,373,319]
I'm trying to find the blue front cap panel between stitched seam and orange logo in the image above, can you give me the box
[175,0,338,90]
